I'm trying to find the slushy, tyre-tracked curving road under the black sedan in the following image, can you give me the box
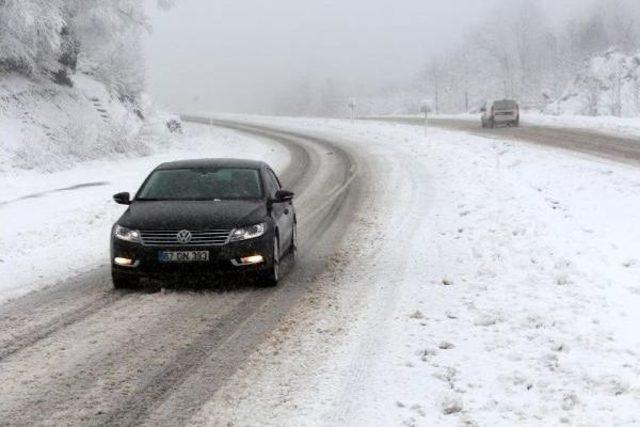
[0,117,367,425]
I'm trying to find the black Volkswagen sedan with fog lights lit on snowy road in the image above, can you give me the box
[111,159,297,288]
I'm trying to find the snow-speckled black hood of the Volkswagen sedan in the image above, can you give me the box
[118,200,267,230]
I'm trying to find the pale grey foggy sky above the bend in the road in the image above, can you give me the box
[146,0,600,114]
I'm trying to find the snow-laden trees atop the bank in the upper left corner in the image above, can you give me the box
[0,0,175,103]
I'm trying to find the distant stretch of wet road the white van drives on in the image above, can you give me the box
[363,116,640,166]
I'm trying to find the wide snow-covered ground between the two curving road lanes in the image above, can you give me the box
[193,115,640,426]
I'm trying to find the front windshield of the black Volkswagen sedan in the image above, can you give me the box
[136,168,262,200]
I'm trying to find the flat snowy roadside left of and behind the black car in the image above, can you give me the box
[0,124,289,301]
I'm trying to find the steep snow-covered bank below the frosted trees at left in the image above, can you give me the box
[0,74,167,174]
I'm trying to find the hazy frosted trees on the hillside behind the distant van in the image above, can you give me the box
[422,0,640,115]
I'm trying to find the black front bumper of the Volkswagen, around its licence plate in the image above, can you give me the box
[111,233,273,277]
